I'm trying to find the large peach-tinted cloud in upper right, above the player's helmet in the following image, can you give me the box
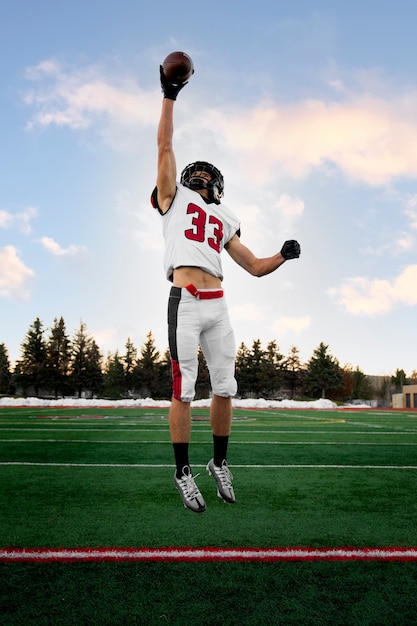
[206,91,417,185]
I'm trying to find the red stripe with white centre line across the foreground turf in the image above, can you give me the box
[0,547,417,563]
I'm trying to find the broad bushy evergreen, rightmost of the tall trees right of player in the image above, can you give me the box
[304,342,343,398]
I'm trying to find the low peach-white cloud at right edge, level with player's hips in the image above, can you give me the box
[328,265,417,316]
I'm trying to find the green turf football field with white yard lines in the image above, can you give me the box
[0,407,417,626]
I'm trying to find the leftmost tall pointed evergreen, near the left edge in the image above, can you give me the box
[15,317,46,396]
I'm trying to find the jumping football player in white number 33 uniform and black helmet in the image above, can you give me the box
[151,67,300,513]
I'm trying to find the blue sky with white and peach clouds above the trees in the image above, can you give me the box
[0,0,417,375]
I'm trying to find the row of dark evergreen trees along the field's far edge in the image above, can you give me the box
[0,317,417,404]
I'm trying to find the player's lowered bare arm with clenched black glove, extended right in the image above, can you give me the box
[225,235,301,276]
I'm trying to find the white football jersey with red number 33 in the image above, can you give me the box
[152,183,240,281]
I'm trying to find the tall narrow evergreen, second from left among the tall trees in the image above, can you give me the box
[46,317,71,398]
